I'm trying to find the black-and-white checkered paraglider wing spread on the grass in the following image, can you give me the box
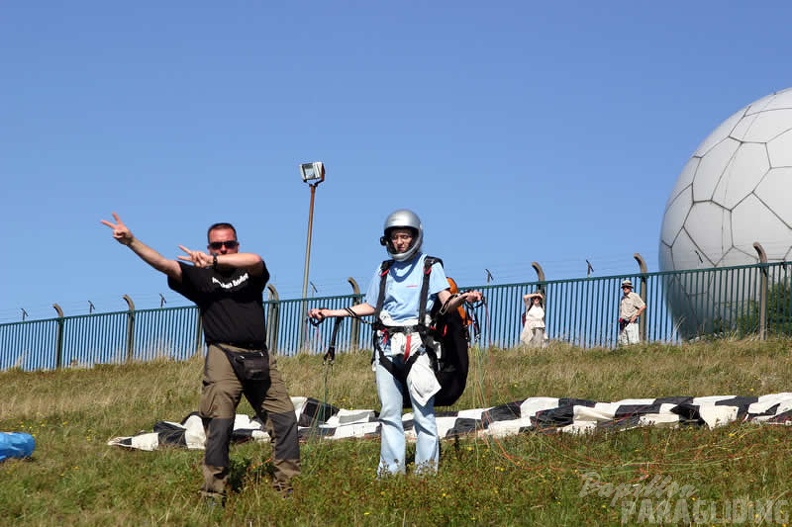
[108,393,792,450]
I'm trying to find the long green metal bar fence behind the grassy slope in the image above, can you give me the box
[0,262,792,371]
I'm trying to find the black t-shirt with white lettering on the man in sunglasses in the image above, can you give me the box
[168,262,269,349]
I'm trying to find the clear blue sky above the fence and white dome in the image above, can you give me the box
[0,0,792,322]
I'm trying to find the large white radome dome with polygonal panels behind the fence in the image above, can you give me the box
[659,88,792,336]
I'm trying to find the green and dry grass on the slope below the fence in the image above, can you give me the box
[0,340,792,526]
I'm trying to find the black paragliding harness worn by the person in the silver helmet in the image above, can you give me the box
[371,256,470,408]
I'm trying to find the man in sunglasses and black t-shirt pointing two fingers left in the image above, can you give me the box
[102,212,300,502]
